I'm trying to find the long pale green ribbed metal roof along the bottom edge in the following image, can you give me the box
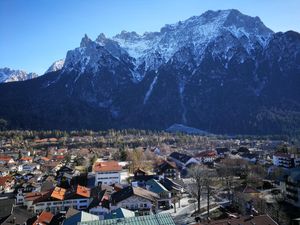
[77,213,175,225]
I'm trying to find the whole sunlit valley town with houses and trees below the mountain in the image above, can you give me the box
[0,130,300,225]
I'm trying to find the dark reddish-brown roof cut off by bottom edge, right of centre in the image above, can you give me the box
[198,214,278,225]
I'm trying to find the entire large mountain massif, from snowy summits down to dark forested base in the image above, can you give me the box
[0,9,300,134]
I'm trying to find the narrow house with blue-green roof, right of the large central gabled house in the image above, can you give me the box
[146,179,172,209]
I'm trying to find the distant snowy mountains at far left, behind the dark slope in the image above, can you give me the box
[0,68,38,83]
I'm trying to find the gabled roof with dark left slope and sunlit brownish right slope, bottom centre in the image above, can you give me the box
[111,186,159,203]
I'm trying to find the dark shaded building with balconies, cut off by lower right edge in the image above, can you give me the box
[280,168,300,208]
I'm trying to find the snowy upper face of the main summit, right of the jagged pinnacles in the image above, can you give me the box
[112,10,273,74]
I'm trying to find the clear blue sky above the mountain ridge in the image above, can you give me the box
[0,0,300,74]
